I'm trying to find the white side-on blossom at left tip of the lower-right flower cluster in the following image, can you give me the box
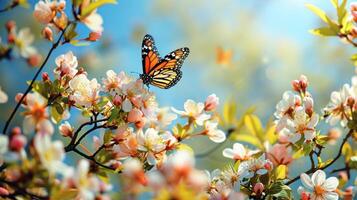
[223,143,259,161]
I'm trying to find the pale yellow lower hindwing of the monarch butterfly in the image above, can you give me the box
[150,68,182,89]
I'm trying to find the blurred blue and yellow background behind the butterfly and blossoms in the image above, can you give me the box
[0,0,355,197]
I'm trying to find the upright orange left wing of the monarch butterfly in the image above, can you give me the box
[141,34,161,74]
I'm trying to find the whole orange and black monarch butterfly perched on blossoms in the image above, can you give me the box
[140,34,190,89]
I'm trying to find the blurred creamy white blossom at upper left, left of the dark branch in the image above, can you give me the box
[14,27,37,58]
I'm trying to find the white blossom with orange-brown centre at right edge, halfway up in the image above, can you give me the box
[324,84,352,127]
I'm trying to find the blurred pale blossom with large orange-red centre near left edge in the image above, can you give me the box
[23,93,54,134]
